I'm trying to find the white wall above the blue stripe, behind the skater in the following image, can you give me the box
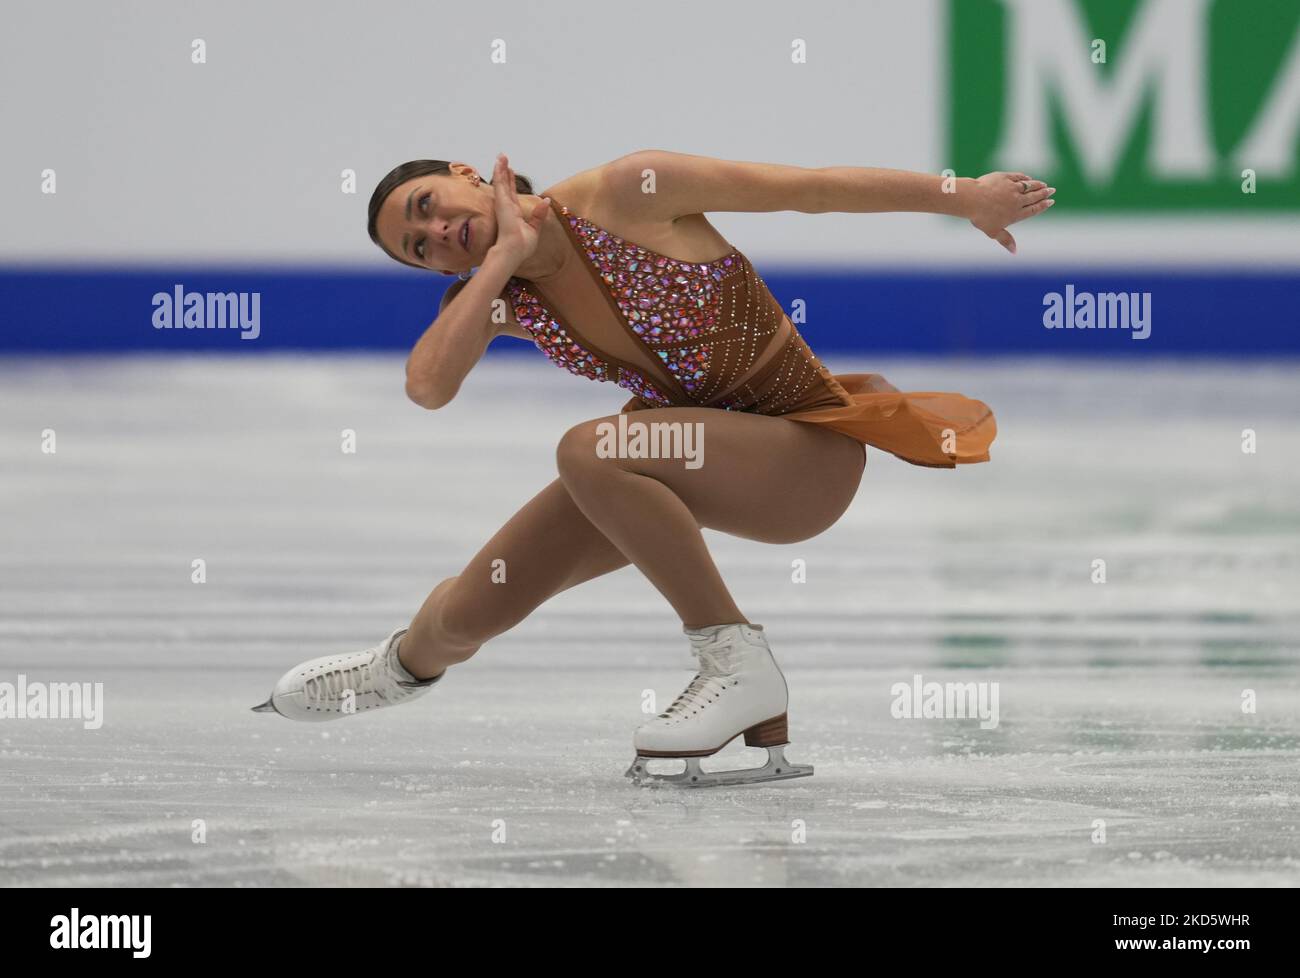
[0,0,1300,268]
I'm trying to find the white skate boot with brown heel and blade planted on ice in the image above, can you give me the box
[627,624,813,788]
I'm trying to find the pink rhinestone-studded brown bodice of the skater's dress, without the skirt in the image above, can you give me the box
[506,200,848,414]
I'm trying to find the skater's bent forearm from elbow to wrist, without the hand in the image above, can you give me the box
[407,251,519,411]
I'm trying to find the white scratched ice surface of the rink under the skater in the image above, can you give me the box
[0,355,1300,886]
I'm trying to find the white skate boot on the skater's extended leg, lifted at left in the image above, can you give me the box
[252,628,446,722]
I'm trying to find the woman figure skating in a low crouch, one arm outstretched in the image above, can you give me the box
[256,151,1056,786]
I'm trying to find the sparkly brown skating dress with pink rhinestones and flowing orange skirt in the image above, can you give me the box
[506,198,997,468]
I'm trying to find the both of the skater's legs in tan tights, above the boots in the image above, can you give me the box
[399,408,866,678]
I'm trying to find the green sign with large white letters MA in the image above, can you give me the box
[948,0,1300,213]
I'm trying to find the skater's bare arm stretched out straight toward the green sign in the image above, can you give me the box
[610,150,1056,254]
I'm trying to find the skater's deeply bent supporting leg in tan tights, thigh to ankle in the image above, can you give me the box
[556,407,866,627]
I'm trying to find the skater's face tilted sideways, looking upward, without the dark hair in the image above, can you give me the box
[374,163,497,274]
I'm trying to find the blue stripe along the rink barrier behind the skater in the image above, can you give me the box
[0,265,1300,356]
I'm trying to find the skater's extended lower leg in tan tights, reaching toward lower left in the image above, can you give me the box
[398,479,628,679]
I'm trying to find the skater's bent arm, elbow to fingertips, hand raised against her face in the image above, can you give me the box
[407,153,550,410]
